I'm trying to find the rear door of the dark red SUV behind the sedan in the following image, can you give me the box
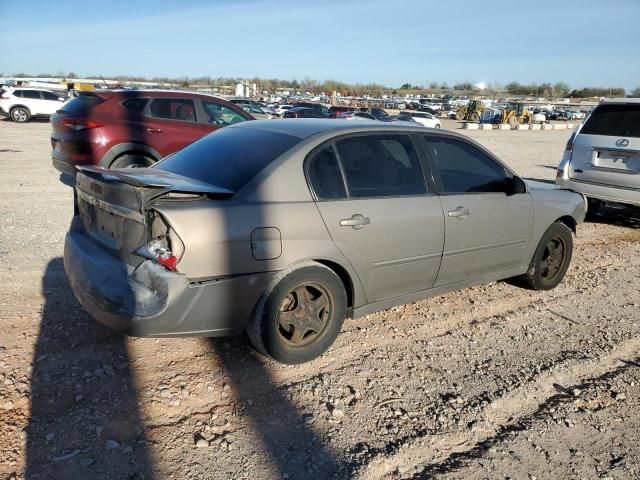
[141,97,213,157]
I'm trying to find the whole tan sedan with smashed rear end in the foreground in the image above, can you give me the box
[64,120,586,363]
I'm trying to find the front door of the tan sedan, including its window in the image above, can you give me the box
[422,135,534,286]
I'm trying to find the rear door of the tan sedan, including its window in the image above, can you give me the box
[307,134,444,302]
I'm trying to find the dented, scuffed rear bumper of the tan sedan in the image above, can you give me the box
[64,218,274,337]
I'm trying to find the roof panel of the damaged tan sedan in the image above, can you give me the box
[225,118,452,139]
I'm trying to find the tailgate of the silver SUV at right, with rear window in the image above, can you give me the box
[569,103,640,189]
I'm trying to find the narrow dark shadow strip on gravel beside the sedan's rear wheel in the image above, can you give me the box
[206,336,344,479]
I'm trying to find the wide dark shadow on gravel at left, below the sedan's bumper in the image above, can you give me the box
[25,258,154,480]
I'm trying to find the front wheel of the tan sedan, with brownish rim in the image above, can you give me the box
[519,222,573,290]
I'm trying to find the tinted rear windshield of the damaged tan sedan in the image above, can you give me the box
[153,128,300,191]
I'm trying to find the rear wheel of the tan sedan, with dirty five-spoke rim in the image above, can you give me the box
[247,262,347,365]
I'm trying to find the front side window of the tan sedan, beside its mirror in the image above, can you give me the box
[425,137,508,193]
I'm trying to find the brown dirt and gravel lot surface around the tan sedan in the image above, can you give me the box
[0,117,640,480]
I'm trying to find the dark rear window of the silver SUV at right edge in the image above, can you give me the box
[580,104,640,138]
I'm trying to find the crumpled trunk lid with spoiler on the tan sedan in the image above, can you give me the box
[76,167,233,267]
